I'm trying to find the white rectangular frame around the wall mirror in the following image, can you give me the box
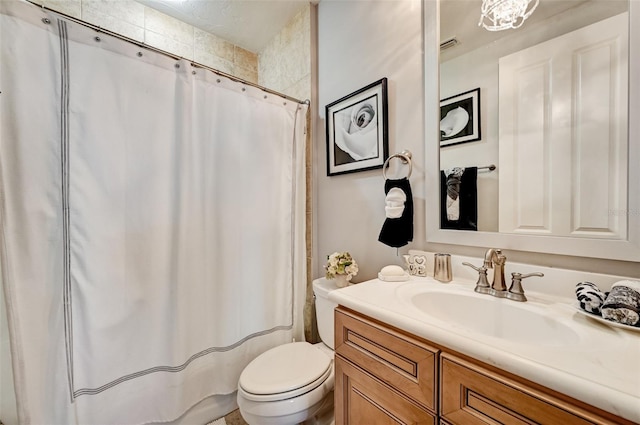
[422,0,640,262]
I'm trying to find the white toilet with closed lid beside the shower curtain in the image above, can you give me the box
[238,278,337,425]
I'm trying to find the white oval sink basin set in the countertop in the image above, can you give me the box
[410,291,580,346]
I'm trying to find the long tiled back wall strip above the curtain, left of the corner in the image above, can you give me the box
[35,0,258,83]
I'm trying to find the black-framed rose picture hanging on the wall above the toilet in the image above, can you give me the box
[325,78,389,176]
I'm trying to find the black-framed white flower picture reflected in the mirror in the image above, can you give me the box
[440,88,481,147]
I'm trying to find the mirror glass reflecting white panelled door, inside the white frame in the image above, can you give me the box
[440,0,629,240]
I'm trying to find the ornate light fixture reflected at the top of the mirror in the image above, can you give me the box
[478,0,540,31]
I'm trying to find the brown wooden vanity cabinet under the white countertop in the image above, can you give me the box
[335,306,637,425]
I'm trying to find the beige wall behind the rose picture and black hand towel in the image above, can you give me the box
[313,0,425,282]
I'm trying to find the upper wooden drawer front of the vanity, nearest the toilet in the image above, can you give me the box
[335,307,438,411]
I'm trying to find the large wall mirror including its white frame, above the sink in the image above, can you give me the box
[423,0,640,261]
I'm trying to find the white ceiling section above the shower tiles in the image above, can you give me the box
[137,0,309,53]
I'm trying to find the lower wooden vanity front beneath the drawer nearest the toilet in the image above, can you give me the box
[335,356,436,425]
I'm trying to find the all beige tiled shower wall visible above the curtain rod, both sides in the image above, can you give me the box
[34,0,311,100]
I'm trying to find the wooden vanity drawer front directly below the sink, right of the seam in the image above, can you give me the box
[440,353,627,425]
